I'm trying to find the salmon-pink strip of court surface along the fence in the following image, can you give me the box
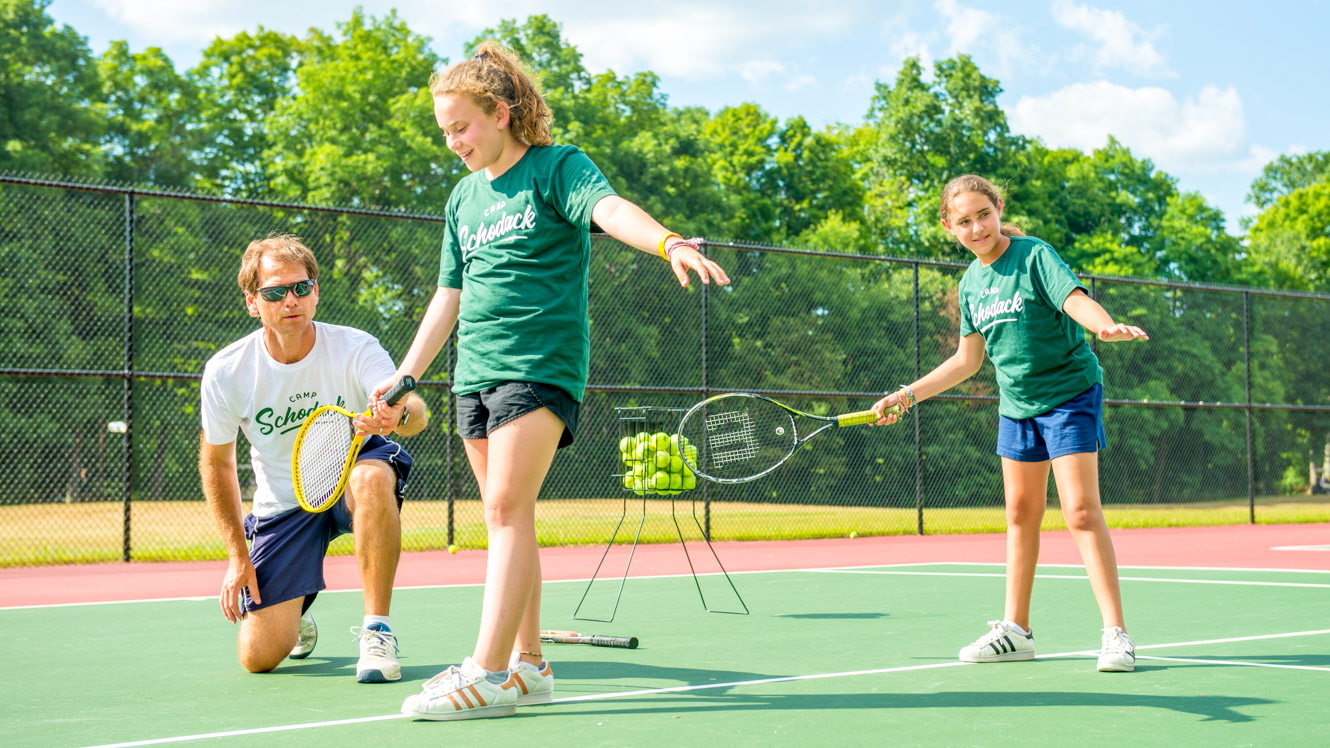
[0,523,1330,607]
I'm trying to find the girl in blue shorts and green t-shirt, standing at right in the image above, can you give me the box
[872,174,1148,672]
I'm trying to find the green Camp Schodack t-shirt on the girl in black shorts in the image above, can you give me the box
[439,145,614,402]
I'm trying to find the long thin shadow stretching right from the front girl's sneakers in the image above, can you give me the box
[531,689,1277,724]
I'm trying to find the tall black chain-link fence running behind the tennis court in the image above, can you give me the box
[0,176,1330,566]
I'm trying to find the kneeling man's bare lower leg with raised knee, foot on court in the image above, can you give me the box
[346,459,402,615]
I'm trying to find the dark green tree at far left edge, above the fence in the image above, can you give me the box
[0,0,101,177]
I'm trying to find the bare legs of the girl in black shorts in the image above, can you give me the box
[464,407,564,671]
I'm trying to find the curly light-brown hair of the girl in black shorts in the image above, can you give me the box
[430,41,555,145]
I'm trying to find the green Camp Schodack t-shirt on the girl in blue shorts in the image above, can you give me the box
[960,237,1104,419]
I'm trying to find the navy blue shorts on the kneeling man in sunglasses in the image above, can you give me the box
[241,434,411,614]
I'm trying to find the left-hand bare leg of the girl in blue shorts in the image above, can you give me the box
[1001,458,1048,631]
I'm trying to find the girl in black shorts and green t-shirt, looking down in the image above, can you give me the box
[364,43,729,720]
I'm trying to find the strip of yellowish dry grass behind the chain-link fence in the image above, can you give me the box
[0,496,1330,567]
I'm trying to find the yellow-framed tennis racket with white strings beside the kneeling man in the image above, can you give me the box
[291,377,415,512]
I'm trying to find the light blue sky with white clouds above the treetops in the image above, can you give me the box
[48,0,1330,233]
